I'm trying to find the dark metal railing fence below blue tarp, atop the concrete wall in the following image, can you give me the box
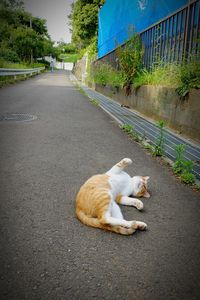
[99,0,200,69]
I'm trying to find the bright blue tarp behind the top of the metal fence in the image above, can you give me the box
[98,0,189,58]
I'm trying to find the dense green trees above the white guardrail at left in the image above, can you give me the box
[0,0,54,62]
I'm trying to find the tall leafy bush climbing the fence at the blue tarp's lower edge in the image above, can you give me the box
[117,35,144,96]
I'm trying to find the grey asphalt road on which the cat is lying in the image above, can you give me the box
[0,72,200,300]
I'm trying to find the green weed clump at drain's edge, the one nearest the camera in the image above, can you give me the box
[173,144,196,184]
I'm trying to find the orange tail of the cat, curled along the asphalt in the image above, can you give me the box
[76,209,135,235]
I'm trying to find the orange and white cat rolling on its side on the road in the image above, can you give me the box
[76,158,150,235]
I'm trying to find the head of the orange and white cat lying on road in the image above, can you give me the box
[133,176,150,198]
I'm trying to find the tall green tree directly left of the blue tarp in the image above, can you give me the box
[68,0,104,49]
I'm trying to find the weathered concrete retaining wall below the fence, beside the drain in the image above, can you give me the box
[95,84,200,142]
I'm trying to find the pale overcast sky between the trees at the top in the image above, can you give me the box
[23,0,75,43]
